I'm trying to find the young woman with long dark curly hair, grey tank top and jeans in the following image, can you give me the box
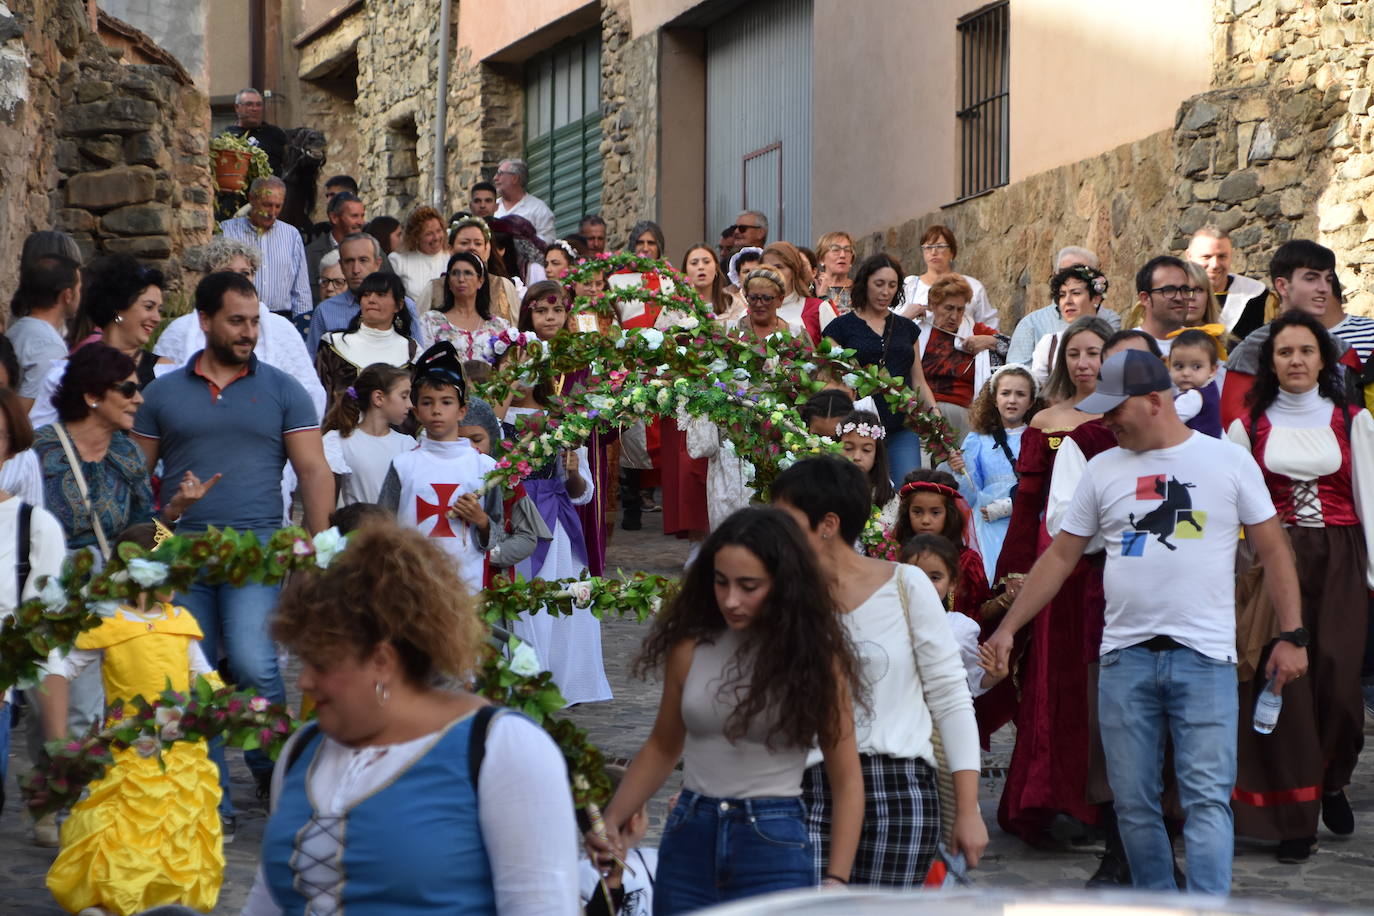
[587,507,863,913]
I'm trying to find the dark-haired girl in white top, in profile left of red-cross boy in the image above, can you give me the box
[324,363,415,508]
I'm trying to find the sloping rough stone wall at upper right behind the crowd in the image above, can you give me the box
[861,0,1374,325]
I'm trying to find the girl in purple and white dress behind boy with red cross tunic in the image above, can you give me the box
[497,280,611,705]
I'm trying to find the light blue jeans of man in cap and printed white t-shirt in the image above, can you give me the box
[1098,647,1238,895]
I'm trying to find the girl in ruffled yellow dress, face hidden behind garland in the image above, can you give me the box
[44,525,224,916]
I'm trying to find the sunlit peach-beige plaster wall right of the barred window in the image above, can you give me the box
[1011,0,1212,181]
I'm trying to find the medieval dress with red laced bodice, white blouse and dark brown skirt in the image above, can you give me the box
[1227,398,1374,840]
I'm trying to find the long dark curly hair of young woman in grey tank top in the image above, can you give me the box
[635,507,863,747]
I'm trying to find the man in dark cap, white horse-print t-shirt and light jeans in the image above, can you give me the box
[988,350,1308,894]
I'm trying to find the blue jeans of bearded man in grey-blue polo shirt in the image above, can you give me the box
[177,582,286,814]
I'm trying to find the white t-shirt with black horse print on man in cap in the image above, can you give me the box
[1062,433,1275,662]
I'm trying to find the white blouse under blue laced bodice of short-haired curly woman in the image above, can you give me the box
[242,714,581,916]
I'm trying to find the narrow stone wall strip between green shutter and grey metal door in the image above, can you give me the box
[600,0,661,247]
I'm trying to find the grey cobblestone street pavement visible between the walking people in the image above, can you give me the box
[0,514,1374,916]
